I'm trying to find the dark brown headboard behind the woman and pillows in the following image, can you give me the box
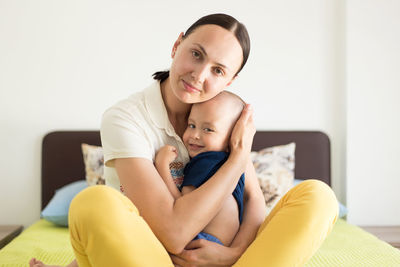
[42,131,331,209]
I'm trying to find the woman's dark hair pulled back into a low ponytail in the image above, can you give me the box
[153,14,250,82]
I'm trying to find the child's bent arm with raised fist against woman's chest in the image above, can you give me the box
[154,145,182,199]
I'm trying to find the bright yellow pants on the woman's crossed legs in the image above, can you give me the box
[69,180,338,267]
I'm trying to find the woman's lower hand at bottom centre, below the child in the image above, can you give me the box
[170,239,241,267]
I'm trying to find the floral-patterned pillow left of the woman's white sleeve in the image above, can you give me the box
[81,144,105,186]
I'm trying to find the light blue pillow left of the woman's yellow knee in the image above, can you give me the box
[41,180,88,226]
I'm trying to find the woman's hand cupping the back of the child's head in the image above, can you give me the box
[230,104,256,159]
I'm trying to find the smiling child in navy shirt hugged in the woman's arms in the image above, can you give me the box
[155,91,245,246]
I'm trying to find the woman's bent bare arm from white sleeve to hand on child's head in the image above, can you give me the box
[115,106,255,254]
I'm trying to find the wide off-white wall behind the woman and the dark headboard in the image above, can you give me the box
[0,0,346,228]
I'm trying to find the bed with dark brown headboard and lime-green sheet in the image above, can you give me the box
[0,131,400,267]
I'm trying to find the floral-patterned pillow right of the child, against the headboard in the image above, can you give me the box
[251,143,296,214]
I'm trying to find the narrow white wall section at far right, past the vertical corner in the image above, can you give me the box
[346,0,400,225]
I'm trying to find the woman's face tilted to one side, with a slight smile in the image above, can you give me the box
[169,24,243,103]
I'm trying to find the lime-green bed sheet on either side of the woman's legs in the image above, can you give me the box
[0,219,400,267]
